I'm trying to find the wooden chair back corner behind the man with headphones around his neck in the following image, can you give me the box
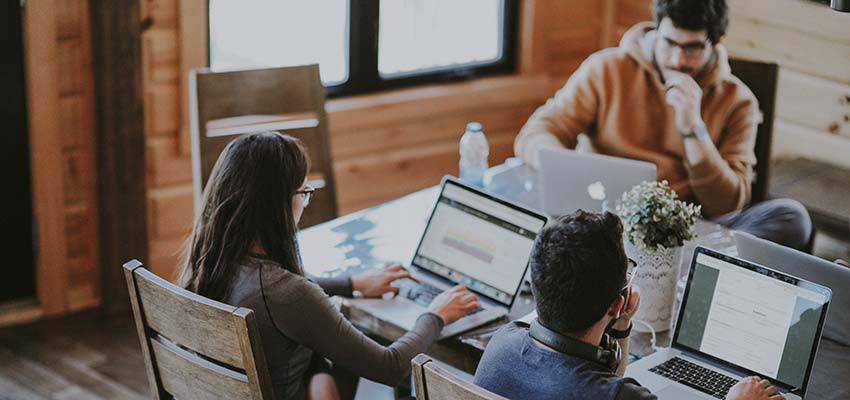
[412,354,507,400]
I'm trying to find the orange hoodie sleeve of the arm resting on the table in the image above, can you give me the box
[514,56,603,169]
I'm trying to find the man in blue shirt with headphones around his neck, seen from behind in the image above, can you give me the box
[475,211,781,400]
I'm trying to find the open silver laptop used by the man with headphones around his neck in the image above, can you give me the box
[626,247,832,399]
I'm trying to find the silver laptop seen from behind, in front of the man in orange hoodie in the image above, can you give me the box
[539,147,658,215]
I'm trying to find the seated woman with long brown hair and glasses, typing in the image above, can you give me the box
[178,132,478,399]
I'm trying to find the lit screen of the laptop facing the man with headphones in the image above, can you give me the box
[673,249,830,388]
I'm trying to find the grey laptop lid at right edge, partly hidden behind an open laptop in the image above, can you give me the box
[732,231,850,346]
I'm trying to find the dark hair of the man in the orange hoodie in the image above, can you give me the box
[652,0,729,44]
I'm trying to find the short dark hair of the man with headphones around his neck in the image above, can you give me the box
[530,210,628,334]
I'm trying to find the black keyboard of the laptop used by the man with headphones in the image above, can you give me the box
[649,357,738,399]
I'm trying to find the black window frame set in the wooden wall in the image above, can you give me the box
[206,0,520,98]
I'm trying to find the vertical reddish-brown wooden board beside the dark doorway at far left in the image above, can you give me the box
[55,0,100,311]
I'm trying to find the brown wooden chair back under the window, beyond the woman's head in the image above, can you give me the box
[189,65,337,226]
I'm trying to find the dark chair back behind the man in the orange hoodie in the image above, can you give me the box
[729,59,779,203]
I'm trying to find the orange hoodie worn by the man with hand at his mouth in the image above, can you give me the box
[514,22,761,217]
